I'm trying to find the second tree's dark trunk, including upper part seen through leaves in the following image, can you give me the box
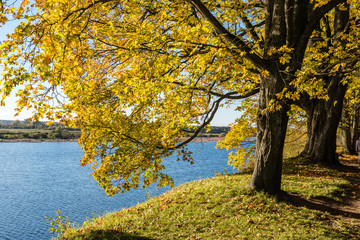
[300,6,349,165]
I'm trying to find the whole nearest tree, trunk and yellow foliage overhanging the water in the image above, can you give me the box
[1,0,356,195]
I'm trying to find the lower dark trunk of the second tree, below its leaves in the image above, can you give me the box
[302,79,346,165]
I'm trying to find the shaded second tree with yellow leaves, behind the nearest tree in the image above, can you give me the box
[297,5,359,164]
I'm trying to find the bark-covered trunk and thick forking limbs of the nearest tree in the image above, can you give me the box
[191,0,345,193]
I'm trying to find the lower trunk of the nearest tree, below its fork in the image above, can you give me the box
[250,75,289,193]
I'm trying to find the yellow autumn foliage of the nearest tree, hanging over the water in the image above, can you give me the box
[1,0,258,195]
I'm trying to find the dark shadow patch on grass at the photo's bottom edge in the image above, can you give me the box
[69,230,153,240]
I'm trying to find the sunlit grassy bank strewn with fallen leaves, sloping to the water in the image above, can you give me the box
[51,160,360,239]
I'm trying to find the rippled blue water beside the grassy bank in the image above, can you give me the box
[0,142,232,240]
